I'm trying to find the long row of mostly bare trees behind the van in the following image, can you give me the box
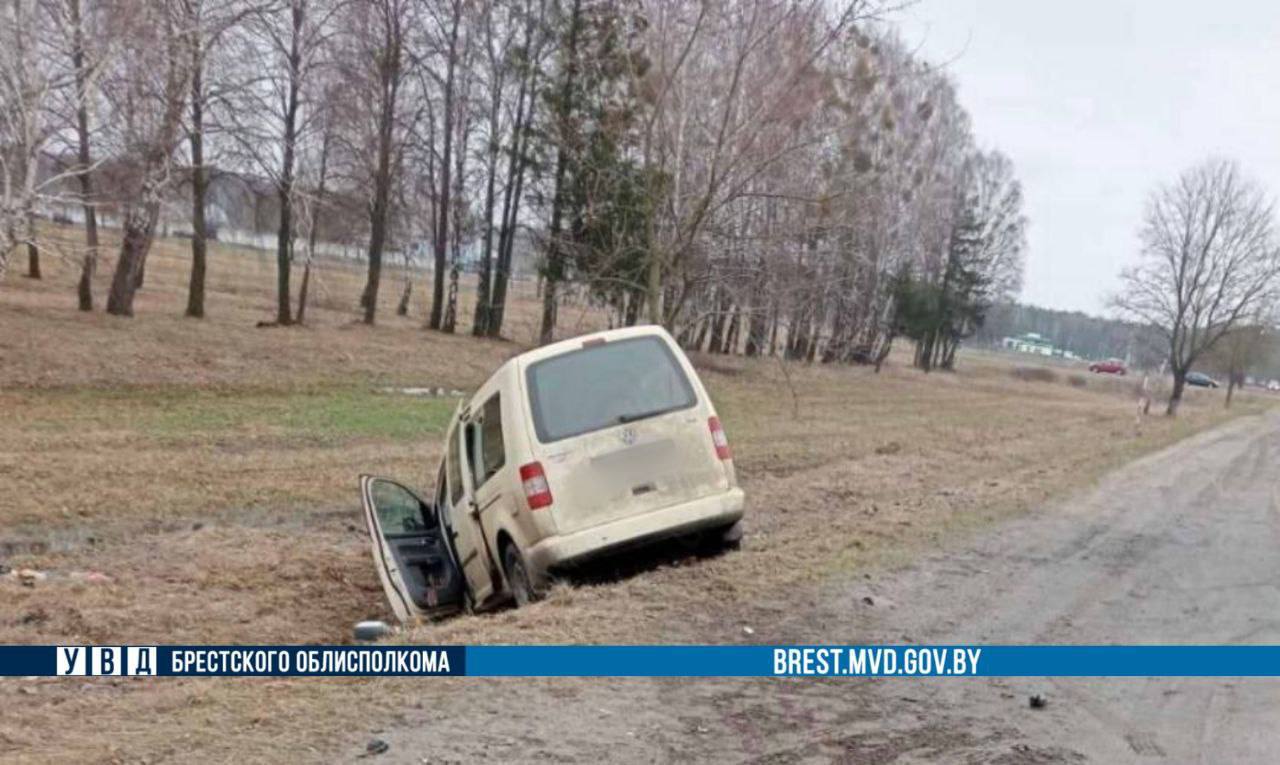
[0,0,1025,368]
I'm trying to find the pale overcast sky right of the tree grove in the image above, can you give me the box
[899,0,1280,313]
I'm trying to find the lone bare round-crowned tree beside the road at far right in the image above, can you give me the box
[1114,160,1280,416]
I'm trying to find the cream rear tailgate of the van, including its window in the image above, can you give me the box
[524,334,728,533]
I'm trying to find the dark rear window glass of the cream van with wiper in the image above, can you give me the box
[526,336,698,444]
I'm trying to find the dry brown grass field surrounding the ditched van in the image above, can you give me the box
[0,232,1272,762]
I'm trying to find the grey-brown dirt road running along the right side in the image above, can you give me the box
[360,414,1280,764]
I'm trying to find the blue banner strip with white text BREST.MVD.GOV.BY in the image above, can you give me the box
[0,645,1280,678]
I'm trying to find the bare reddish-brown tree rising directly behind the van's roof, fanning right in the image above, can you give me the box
[634,0,878,324]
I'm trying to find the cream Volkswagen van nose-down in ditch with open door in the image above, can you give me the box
[360,326,742,622]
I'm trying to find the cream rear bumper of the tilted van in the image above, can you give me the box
[526,487,744,572]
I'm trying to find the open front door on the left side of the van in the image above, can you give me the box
[360,476,466,624]
